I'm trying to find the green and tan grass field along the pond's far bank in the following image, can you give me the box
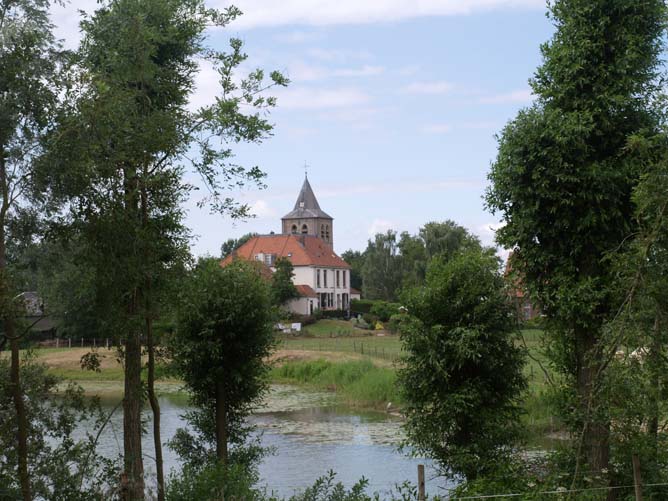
[11,319,559,434]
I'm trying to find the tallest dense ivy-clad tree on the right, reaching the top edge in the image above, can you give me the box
[486,0,665,477]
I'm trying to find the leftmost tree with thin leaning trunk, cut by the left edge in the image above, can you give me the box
[0,0,61,500]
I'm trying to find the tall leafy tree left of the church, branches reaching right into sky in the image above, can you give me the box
[43,0,287,500]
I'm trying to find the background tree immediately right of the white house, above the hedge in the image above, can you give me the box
[362,230,403,301]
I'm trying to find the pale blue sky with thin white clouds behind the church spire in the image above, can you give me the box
[52,0,553,256]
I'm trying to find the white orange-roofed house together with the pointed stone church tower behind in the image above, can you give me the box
[221,177,359,315]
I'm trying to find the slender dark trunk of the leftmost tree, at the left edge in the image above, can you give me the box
[0,148,32,501]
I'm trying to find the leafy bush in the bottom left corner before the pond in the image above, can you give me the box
[0,355,118,501]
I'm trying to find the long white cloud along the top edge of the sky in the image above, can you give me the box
[220,0,545,28]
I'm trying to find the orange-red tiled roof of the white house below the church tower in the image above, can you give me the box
[221,235,350,268]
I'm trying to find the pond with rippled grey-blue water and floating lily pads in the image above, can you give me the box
[90,385,448,497]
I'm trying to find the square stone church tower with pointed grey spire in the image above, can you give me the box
[281,176,334,247]
